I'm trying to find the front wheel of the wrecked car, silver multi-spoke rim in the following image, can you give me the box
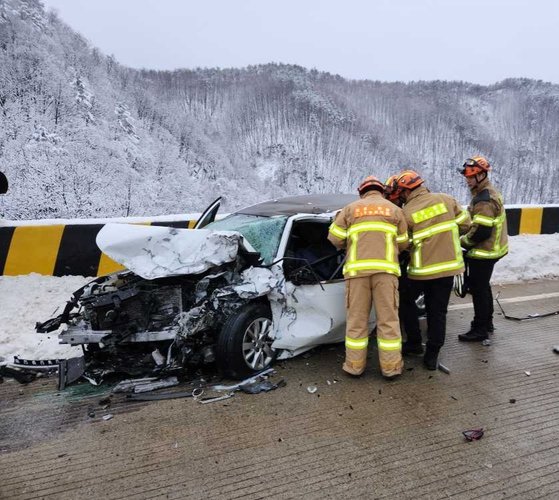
[216,303,277,378]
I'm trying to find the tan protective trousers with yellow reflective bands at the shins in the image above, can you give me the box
[343,273,404,377]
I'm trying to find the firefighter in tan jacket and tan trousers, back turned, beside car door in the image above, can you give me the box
[328,176,408,379]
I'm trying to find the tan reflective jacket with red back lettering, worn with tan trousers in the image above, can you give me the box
[328,191,408,278]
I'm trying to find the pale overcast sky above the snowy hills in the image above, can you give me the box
[43,0,559,84]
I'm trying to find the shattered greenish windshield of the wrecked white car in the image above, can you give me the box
[204,214,287,264]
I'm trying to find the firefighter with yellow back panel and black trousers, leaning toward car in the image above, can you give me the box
[395,170,470,370]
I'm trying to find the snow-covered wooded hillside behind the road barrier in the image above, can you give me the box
[0,0,559,219]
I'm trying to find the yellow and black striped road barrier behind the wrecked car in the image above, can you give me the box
[0,205,559,276]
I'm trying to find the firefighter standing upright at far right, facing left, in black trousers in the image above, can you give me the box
[458,156,508,342]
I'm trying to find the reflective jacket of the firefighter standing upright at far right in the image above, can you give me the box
[461,178,509,259]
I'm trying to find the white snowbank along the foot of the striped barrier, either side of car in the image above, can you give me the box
[0,234,559,362]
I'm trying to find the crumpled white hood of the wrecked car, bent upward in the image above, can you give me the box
[96,224,255,280]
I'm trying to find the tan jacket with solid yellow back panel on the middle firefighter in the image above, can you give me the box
[404,186,470,280]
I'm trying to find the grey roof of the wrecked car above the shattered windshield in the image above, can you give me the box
[235,193,359,217]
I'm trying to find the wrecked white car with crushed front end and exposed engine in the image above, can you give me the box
[37,195,374,378]
